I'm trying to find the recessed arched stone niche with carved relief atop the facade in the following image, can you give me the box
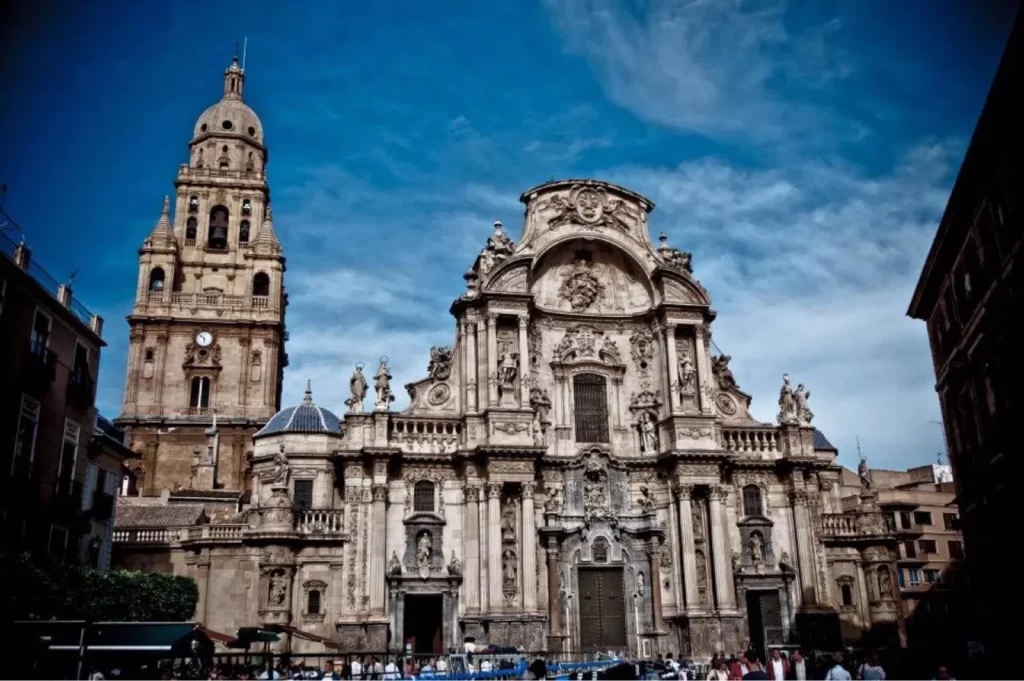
[529,238,654,314]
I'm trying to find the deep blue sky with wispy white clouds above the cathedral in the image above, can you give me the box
[0,0,1012,467]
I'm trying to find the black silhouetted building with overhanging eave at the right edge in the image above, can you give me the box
[908,7,1024,673]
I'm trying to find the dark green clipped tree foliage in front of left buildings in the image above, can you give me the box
[0,555,199,622]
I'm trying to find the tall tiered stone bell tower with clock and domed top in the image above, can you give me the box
[118,55,288,496]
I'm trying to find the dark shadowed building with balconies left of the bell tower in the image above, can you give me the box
[0,223,133,569]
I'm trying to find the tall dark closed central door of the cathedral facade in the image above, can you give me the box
[579,567,629,651]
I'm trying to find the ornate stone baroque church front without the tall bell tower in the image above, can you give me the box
[117,104,899,658]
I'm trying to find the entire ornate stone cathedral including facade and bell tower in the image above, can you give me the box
[115,57,901,659]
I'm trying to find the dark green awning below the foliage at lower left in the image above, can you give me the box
[14,622,213,656]
